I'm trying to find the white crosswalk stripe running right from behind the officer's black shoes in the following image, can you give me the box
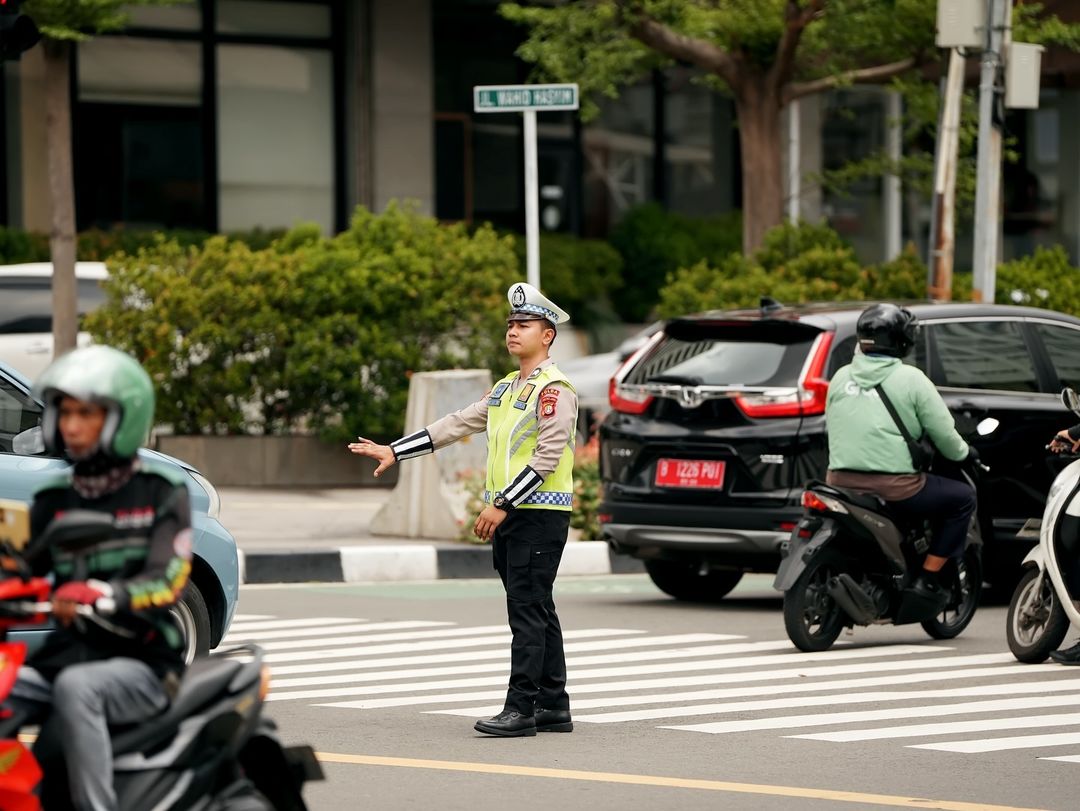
[424,664,1062,721]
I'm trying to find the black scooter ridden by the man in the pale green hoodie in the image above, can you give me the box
[773,460,983,651]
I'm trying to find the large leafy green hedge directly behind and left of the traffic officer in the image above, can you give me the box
[86,205,517,441]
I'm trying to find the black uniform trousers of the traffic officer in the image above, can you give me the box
[491,510,570,715]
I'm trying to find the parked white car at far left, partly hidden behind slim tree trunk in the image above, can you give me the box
[0,262,108,380]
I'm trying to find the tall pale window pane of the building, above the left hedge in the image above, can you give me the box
[217,44,334,232]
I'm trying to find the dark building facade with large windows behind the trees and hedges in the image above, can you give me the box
[0,0,1080,267]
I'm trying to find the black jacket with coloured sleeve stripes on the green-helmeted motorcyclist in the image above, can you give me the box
[27,460,191,680]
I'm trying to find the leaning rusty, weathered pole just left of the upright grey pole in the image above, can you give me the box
[928,49,963,301]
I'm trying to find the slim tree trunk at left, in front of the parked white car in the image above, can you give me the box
[42,39,79,357]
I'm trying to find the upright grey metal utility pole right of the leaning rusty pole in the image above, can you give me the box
[972,0,1012,301]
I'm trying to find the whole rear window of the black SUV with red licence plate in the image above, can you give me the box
[623,322,816,387]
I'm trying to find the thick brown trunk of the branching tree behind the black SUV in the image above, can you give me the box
[735,85,784,254]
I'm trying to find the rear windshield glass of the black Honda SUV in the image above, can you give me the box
[624,336,813,387]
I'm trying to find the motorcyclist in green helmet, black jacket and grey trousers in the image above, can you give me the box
[11,347,191,811]
